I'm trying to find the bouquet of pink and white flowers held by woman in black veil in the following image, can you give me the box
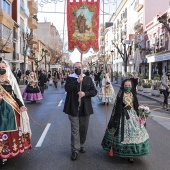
[137,105,150,126]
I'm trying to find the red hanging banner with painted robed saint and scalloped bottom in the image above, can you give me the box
[67,0,100,53]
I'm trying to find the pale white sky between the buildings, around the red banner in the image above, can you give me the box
[37,0,121,62]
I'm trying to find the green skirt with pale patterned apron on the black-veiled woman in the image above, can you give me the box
[102,109,149,158]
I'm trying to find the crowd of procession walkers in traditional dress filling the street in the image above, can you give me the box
[0,60,150,166]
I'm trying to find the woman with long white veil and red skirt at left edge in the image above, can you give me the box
[0,58,31,167]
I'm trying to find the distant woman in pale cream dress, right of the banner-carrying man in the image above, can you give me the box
[98,73,115,105]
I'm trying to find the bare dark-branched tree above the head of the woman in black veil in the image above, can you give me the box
[112,39,132,73]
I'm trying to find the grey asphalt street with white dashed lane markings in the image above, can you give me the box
[2,86,170,170]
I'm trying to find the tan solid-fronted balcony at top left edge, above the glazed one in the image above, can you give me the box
[0,8,14,30]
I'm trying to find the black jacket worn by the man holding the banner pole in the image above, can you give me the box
[63,76,97,116]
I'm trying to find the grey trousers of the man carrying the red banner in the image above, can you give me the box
[68,115,90,152]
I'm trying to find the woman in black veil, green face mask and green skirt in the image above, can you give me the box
[102,79,149,162]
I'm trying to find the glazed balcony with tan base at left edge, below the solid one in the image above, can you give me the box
[0,24,14,53]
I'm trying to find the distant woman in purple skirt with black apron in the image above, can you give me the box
[23,72,43,102]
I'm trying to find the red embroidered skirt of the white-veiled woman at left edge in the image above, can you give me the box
[0,111,31,159]
